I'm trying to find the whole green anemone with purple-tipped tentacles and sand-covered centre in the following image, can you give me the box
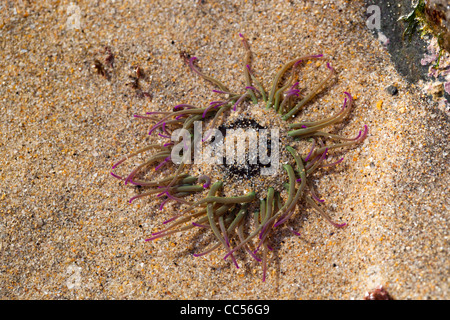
[111,34,368,281]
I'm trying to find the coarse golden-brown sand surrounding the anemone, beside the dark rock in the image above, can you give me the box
[0,0,450,300]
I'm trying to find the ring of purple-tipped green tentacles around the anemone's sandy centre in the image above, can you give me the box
[111,34,368,281]
